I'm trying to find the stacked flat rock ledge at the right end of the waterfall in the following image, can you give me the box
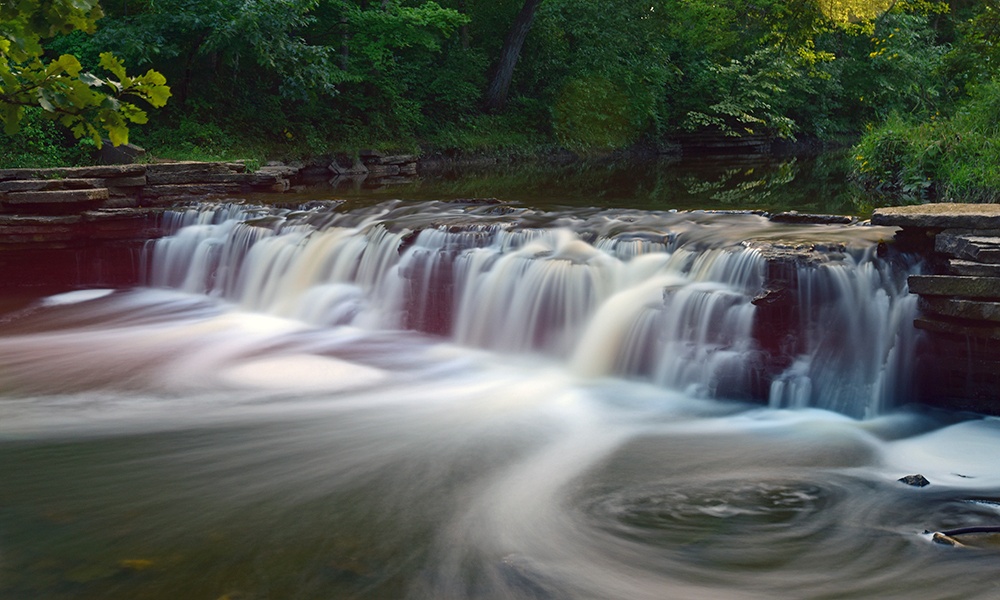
[872,204,1000,414]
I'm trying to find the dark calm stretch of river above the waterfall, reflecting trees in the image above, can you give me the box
[300,151,873,215]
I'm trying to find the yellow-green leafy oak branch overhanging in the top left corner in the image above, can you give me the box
[0,0,170,147]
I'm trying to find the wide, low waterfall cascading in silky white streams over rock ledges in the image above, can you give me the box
[147,201,915,417]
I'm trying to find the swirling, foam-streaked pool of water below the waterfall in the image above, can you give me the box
[0,290,1000,600]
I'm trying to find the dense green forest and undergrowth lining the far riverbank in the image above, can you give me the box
[0,0,1000,201]
